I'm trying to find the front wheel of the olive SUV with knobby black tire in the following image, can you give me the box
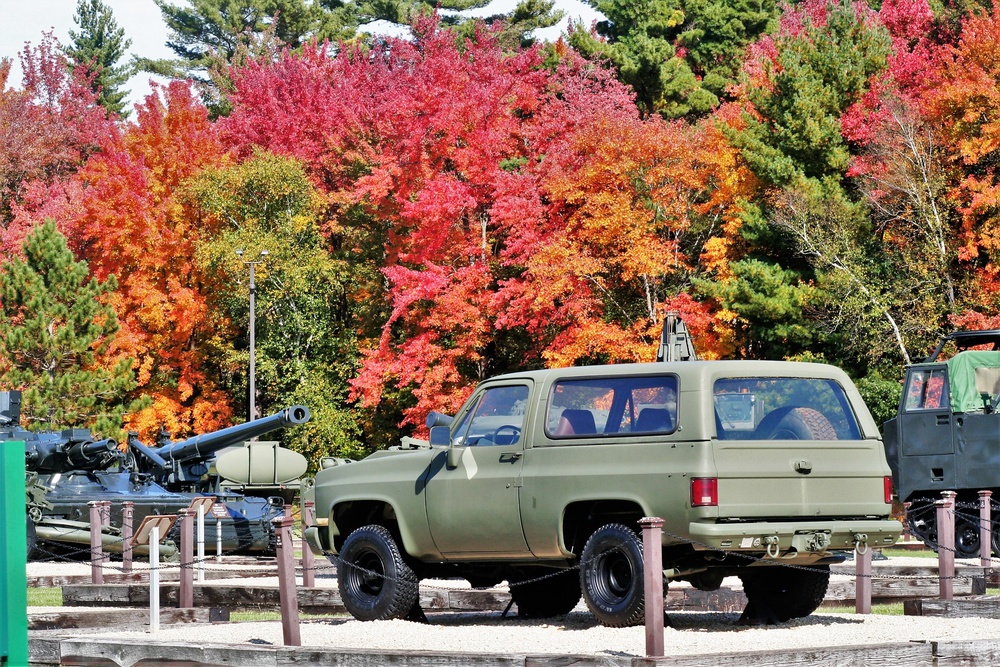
[338,525,420,621]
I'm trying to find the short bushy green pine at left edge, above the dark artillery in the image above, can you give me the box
[0,220,142,434]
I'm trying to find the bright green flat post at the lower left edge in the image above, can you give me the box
[0,440,28,667]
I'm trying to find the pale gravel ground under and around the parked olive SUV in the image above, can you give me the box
[29,558,1000,656]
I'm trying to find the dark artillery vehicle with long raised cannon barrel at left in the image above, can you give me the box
[0,391,310,555]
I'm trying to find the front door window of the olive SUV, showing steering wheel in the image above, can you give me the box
[452,384,528,445]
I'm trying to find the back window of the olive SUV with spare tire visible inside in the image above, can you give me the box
[713,377,861,440]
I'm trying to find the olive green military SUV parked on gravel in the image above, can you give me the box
[306,361,901,626]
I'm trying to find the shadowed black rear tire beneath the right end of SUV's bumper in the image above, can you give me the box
[740,565,830,623]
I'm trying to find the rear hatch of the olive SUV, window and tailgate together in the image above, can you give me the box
[714,377,888,521]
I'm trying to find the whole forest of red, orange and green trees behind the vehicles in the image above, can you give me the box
[0,0,1000,463]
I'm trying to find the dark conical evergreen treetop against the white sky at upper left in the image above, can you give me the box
[66,0,132,118]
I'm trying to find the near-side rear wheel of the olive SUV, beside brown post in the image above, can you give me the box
[580,523,646,628]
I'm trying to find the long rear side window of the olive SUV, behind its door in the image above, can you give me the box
[545,375,677,439]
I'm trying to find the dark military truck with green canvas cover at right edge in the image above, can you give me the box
[883,330,1000,558]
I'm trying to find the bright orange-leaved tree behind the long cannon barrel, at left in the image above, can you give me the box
[7,82,232,439]
